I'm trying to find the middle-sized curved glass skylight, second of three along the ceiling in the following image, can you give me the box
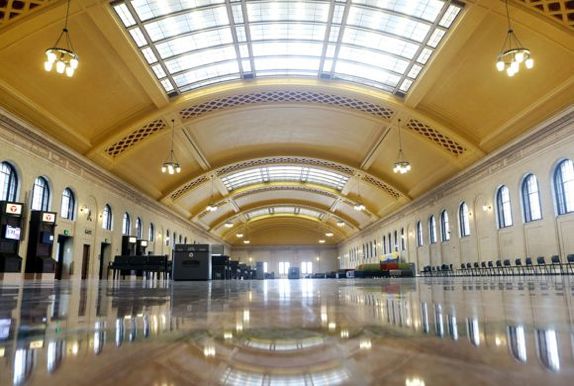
[221,166,349,191]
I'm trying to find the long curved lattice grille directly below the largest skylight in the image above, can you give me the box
[179,91,394,120]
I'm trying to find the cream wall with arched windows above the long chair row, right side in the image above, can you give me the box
[339,107,574,270]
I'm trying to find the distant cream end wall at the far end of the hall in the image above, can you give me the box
[231,245,338,277]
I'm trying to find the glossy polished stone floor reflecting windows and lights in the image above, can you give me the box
[0,277,574,386]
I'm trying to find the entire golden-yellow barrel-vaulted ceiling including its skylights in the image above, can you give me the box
[0,0,574,244]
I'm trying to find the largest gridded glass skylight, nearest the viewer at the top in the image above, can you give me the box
[112,0,468,96]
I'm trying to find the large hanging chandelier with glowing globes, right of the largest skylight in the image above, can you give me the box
[496,0,534,76]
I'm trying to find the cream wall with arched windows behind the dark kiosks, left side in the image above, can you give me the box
[0,111,227,277]
